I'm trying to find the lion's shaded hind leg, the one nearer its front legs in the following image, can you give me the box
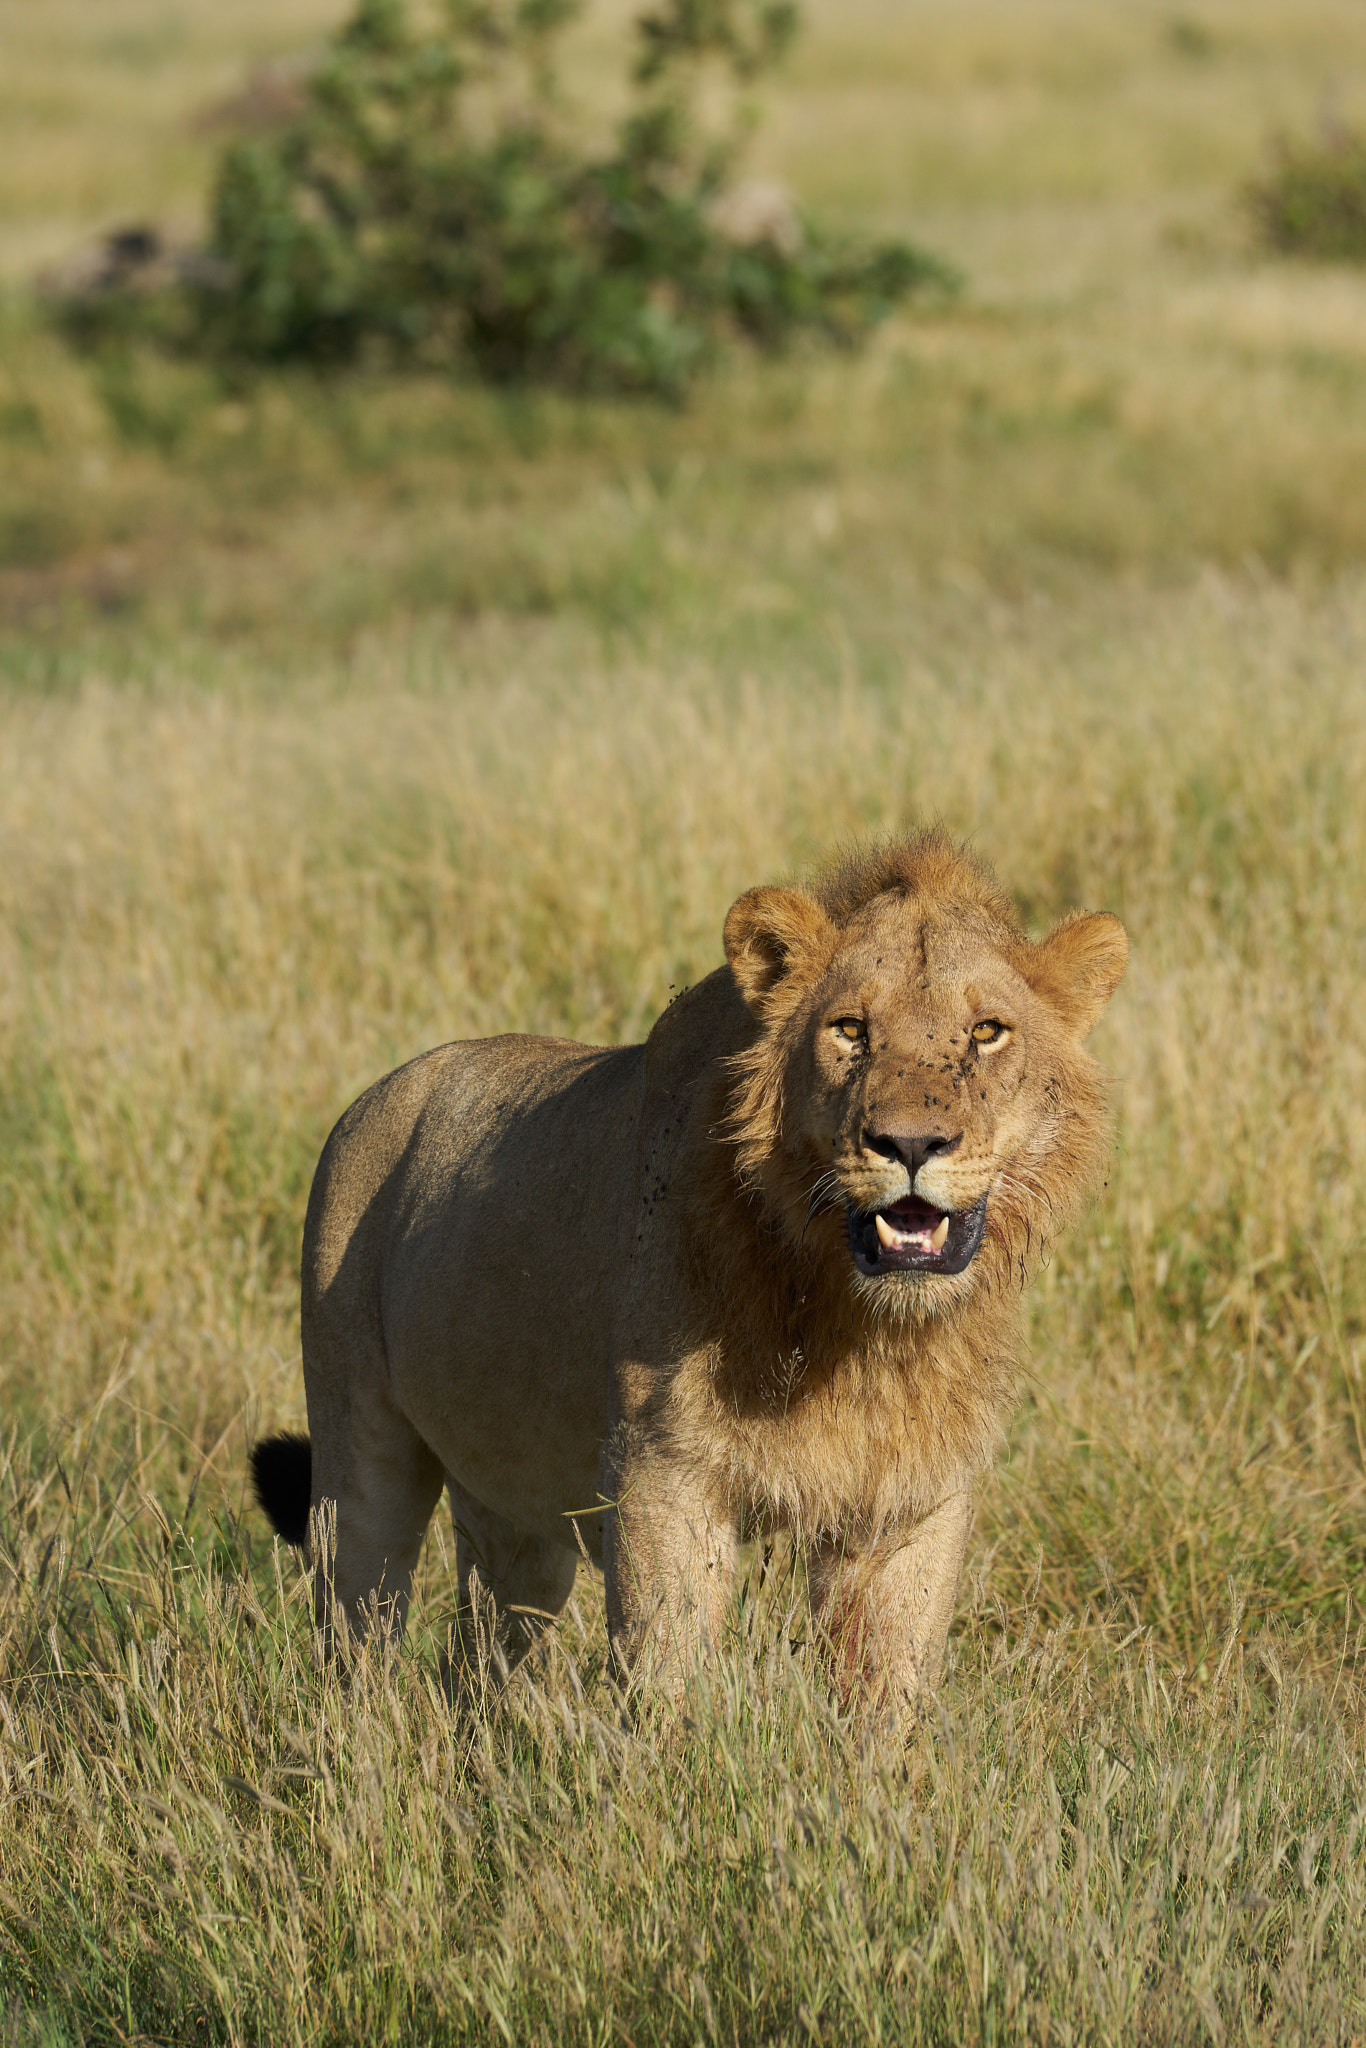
[446,1473,578,1667]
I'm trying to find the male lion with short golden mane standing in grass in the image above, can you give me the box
[252,829,1126,1700]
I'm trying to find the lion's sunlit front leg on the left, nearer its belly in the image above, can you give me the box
[602,1454,737,1698]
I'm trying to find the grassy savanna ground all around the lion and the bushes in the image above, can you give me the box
[0,0,1366,2048]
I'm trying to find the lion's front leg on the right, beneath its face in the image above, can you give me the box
[809,1483,973,1710]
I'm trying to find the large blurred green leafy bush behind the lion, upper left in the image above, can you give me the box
[162,0,950,393]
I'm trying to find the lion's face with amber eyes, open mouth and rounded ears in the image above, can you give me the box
[727,851,1126,1307]
